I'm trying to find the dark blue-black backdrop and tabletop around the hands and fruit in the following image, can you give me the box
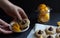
[0,0,60,38]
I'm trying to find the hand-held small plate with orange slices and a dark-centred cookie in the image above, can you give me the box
[10,19,30,32]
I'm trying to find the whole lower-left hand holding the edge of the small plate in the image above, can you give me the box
[0,19,12,34]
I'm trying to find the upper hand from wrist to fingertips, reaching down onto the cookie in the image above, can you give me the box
[4,5,28,20]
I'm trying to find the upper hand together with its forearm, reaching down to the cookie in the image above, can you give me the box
[1,0,28,20]
